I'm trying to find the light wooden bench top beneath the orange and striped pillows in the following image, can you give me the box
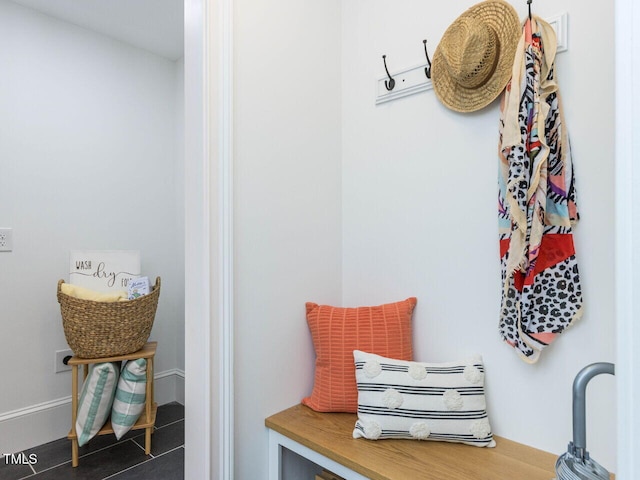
[265,405,558,480]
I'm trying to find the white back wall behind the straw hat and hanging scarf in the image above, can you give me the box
[342,0,616,470]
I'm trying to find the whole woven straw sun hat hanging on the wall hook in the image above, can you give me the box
[432,0,522,112]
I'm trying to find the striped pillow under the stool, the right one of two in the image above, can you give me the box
[111,358,147,440]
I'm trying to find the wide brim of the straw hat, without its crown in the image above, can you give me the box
[431,0,522,113]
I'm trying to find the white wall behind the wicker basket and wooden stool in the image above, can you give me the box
[0,0,184,452]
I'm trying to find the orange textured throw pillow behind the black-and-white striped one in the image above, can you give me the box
[302,297,417,413]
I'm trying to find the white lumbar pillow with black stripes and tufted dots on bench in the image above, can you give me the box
[353,350,495,447]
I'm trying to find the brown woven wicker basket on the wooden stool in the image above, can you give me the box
[58,277,160,358]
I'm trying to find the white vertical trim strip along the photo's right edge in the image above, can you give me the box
[614,0,640,479]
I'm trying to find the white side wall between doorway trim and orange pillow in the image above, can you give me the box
[234,0,341,478]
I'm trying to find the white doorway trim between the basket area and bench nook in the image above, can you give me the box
[184,0,234,480]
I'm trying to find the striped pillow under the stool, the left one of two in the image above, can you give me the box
[76,363,118,446]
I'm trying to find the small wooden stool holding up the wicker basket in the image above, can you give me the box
[67,342,158,467]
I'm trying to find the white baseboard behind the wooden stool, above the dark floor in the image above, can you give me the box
[0,368,184,456]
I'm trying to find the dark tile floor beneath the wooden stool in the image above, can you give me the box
[0,403,184,480]
